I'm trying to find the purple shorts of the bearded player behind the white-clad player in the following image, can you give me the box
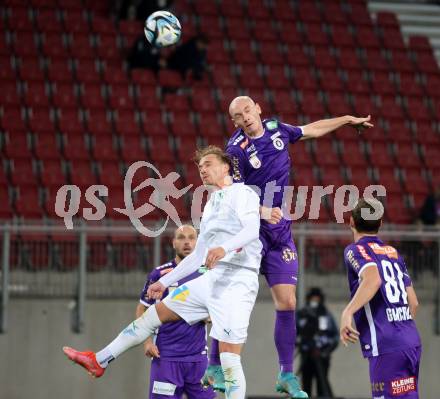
[149,359,215,399]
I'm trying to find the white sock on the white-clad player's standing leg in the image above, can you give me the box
[220,352,246,399]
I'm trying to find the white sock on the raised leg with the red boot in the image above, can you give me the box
[96,305,162,368]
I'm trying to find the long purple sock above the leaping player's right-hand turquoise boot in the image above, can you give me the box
[274,310,296,372]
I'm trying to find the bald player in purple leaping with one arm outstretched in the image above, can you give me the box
[204,96,372,398]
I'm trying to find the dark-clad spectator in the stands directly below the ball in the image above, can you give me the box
[127,34,167,73]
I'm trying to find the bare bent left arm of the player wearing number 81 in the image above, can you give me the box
[339,266,382,346]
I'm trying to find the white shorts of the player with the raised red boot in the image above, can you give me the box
[163,264,258,344]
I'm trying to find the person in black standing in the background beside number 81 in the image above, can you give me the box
[297,287,339,398]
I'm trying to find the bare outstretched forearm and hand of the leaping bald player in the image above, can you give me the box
[301,115,374,140]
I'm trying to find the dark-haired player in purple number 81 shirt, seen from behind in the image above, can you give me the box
[340,199,422,399]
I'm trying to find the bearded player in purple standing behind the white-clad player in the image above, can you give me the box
[136,225,216,399]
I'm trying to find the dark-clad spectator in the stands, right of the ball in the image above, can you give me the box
[168,34,208,80]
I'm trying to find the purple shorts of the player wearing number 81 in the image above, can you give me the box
[368,346,422,399]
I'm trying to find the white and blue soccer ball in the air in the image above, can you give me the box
[144,11,182,47]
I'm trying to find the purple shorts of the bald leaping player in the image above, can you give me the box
[260,231,298,287]
